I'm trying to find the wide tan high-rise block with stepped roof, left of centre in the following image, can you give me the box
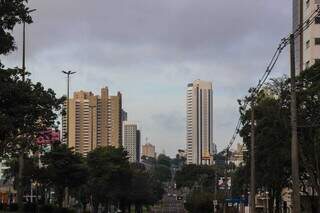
[62,87,122,155]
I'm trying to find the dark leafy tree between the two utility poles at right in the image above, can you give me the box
[240,78,291,212]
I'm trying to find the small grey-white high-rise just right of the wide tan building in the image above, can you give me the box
[123,121,141,162]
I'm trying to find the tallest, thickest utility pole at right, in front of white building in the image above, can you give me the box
[290,34,301,213]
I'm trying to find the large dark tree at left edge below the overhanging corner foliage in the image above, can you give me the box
[0,69,64,209]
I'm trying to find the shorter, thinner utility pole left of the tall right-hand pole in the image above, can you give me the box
[250,100,256,213]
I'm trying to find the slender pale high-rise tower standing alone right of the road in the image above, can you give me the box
[186,80,213,165]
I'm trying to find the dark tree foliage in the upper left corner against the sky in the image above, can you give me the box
[0,0,32,63]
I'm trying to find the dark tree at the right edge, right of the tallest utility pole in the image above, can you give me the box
[297,63,320,212]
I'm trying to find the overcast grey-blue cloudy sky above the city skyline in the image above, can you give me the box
[1,0,292,155]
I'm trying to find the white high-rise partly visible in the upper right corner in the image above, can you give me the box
[292,0,320,73]
